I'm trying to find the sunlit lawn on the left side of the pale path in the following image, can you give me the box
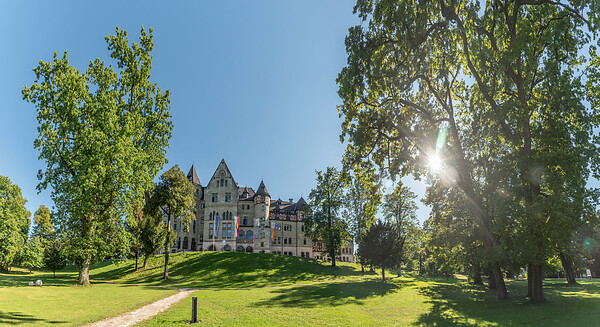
[0,269,177,326]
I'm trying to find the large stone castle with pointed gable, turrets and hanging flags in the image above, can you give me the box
[165,159,354,262]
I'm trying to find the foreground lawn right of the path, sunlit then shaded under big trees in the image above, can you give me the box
[137,277,600,326]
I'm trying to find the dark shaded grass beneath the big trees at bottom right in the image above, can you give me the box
[416,279,600,326]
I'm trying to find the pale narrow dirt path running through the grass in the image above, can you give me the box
[86,289,194,327]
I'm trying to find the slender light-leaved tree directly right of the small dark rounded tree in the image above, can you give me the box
[383,182,417,275]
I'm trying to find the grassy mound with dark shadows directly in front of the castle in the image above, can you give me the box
[90,252,363,288]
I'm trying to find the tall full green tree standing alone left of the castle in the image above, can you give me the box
[22,27,173,285]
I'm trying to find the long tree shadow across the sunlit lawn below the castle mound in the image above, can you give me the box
[255,280,412,308]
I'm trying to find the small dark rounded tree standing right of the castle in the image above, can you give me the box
[358,221,404,282]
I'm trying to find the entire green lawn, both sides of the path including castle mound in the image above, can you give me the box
[0,252,600,326]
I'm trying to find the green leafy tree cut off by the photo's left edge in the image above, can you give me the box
[0,175,31,270]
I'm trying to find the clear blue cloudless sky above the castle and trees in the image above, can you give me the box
[0,0,428,226]
